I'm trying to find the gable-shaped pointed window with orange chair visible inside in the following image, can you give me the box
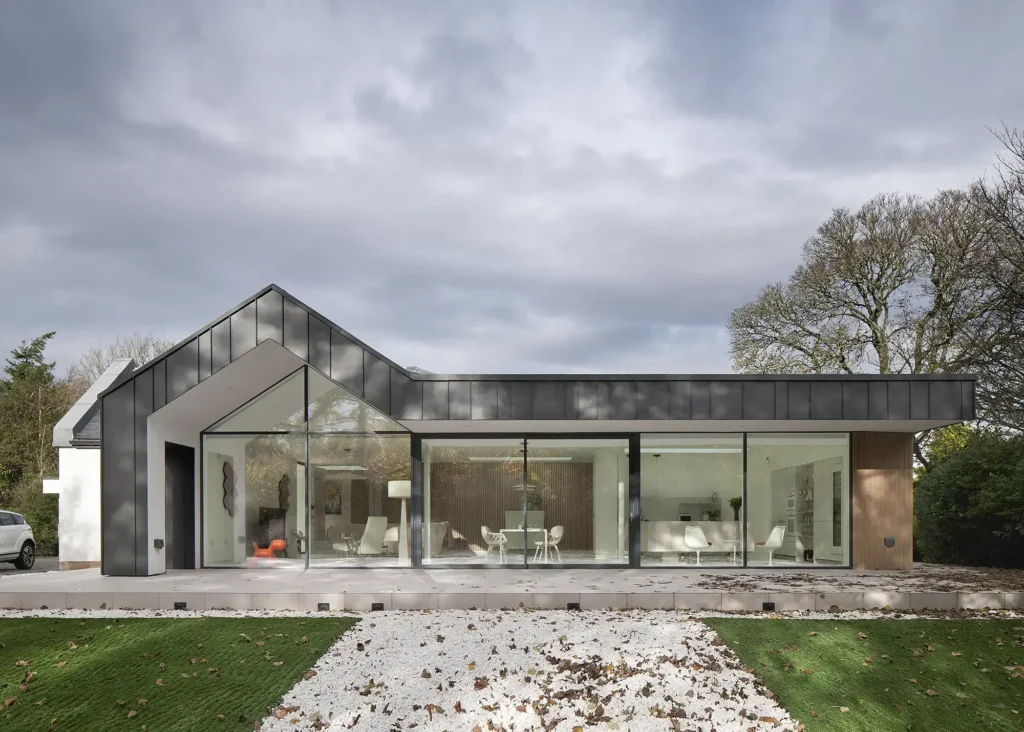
[203,368,412,566]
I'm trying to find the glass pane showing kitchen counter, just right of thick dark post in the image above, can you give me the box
[640,434,743,566]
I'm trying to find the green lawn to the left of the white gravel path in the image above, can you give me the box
[0,617,355,732]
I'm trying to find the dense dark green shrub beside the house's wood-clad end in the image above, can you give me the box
[914,434,1024,567]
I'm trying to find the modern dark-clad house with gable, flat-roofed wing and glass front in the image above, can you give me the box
[100,286,975,575]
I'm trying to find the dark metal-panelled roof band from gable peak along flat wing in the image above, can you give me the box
[100,285,975,429]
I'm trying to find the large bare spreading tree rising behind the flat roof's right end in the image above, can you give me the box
[729,190,993,462]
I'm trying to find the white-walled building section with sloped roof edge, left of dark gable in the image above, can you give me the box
[43,358,136,569]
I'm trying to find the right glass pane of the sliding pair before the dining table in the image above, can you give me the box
[516,438,629,565]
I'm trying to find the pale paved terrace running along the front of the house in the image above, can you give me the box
[0,565,1024,611]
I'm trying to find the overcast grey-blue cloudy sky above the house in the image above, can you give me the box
[0,0,1024,373]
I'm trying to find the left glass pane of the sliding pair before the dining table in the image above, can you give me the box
[422,438,525,566]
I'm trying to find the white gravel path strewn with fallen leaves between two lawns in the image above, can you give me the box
[262,610,797,732]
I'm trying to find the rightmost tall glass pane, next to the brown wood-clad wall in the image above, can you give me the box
[746,433,850,566]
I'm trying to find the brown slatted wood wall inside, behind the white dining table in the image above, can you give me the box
[430,462,594,551]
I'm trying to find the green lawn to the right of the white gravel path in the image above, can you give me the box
[707,617,1024,732]
